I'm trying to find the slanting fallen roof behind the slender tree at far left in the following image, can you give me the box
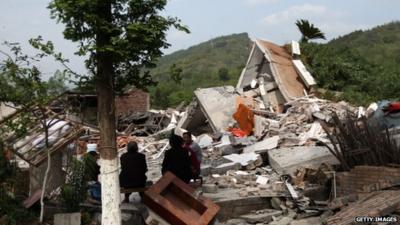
[0,107,85,166]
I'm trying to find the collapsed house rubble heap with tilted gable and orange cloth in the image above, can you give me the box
[5,40,400,225]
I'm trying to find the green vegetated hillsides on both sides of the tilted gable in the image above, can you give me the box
[150,22,400,108]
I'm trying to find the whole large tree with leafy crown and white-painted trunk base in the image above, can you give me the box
[49,0,188,225]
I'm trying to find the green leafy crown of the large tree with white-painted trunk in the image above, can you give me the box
[49,0,189,92]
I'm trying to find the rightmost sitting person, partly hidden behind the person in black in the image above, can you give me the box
[183,131,203,178]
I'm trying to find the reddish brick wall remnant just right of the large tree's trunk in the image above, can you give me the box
[115,89,150,116]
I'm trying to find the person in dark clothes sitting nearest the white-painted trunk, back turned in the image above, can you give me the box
[119,141,147,202]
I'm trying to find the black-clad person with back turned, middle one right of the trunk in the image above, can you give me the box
[161,135,192,183]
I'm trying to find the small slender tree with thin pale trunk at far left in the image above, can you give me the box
[0,41,65,222]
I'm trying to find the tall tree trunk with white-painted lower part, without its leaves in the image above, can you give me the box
[95,1,121,225]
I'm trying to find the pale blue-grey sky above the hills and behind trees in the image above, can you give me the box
[0,0,400,78]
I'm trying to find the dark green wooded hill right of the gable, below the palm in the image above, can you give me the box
[302,22,400,105]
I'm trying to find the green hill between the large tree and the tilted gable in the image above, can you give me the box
[150,33,251,108]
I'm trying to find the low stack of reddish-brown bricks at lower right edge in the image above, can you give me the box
[336,166,400,197]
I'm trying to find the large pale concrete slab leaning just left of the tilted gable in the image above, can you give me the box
[194,86,238,132]
